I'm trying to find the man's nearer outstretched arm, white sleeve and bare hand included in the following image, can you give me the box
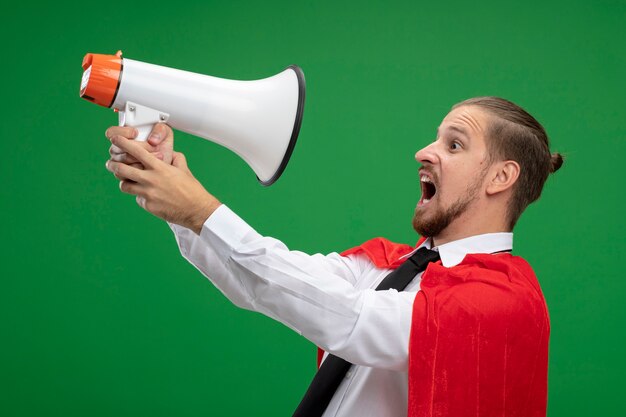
[107,132,415,371]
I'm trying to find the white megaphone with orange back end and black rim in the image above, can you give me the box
[80,51,305,185]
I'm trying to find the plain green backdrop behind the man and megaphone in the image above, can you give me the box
[0,0,626,416]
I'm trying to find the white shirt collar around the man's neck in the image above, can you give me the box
[408,232,513,268]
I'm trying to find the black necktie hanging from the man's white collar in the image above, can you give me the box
[293,248,439,417]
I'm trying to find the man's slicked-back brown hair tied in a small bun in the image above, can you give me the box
[452,97,563,229]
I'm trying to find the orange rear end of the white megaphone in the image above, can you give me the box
[80,51,123,107]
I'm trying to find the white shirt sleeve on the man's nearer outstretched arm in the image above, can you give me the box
[170,205,415,371]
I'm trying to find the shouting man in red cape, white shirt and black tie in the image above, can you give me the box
[106,97,562,416]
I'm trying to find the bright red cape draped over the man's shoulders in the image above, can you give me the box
[332,238,550,417]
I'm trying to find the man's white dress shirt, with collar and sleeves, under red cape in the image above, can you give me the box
[170,205,513,417]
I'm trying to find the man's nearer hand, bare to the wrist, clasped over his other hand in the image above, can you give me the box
[106,136,221,234]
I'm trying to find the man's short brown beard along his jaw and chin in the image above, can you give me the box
[413,170,487,237]
